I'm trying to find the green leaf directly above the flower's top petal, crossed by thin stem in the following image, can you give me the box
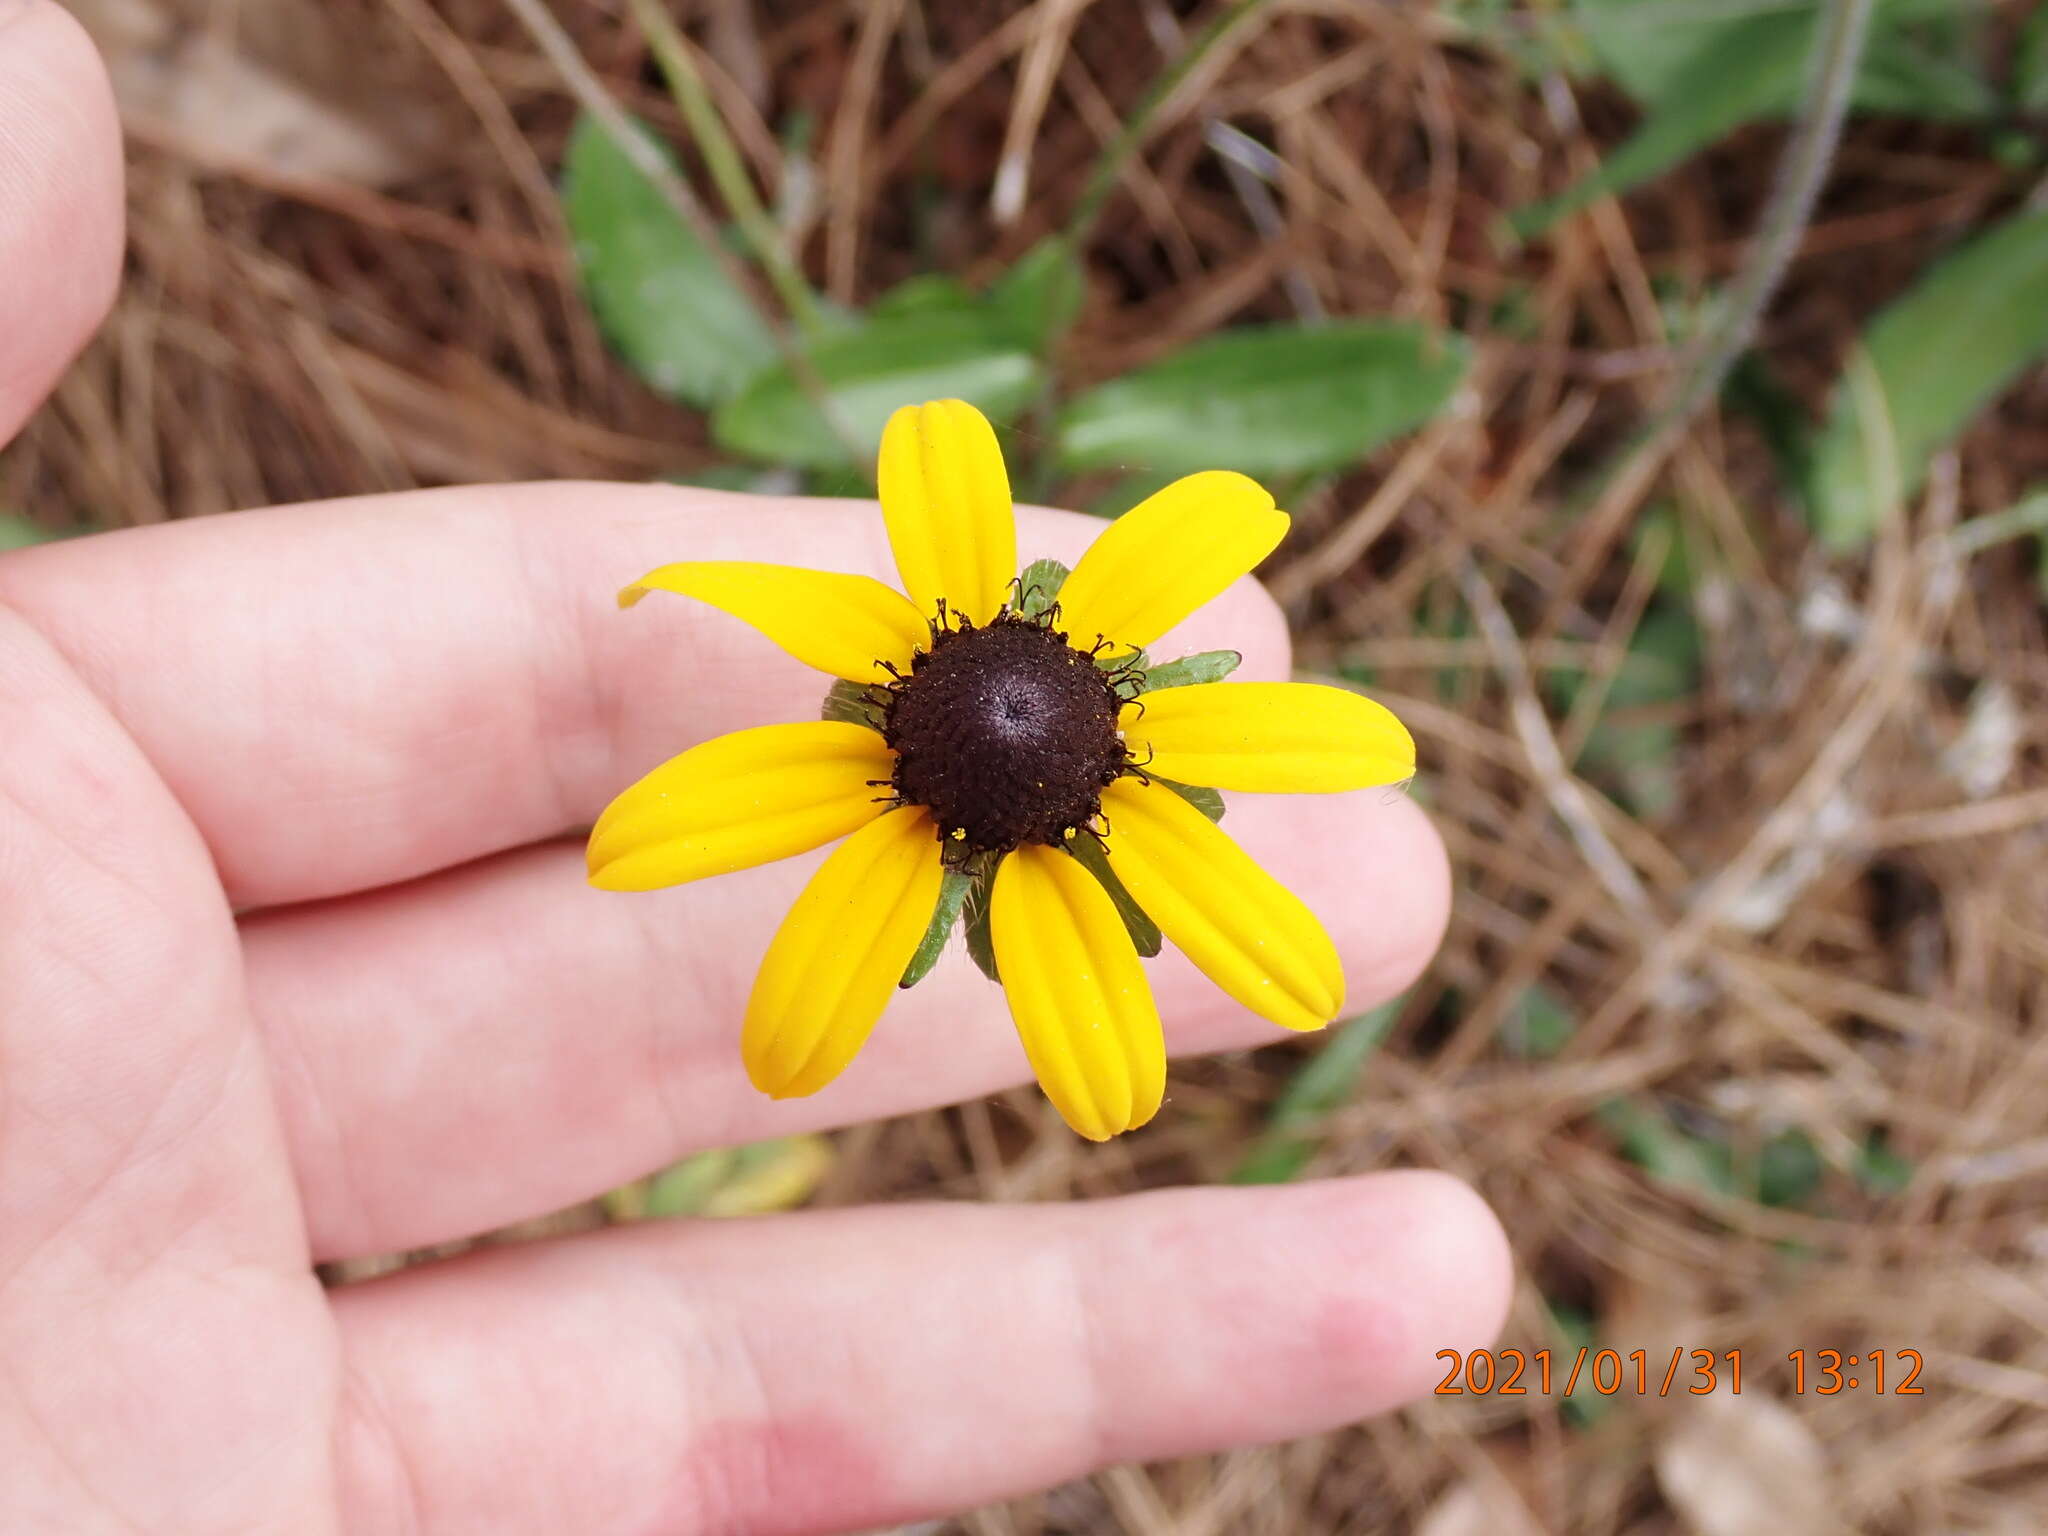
[711,309,1044,467]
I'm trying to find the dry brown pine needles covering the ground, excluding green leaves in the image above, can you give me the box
[16,0,2048,1536]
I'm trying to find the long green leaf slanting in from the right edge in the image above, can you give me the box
[1808,209,2048,551]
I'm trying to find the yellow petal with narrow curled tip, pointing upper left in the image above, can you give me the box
[618,559,932,682]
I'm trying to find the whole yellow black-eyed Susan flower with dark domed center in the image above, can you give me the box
[590,399,1415,1141]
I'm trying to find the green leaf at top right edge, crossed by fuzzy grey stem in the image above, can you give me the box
[1511,0,1999,238]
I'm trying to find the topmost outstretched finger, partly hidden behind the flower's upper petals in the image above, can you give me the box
[0,483,1286,907]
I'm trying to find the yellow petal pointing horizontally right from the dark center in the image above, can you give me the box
[1118,682,1415,795]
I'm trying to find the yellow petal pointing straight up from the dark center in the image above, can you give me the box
[874,399,1018,625]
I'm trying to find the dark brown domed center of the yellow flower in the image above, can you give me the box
[883,612,1126,856]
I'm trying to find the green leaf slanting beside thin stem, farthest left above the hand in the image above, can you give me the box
[561,117,776,406]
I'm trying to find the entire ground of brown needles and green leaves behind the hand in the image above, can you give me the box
[16,0,2048,1536]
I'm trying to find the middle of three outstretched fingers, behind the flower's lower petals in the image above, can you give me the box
[244,791,1448,1257]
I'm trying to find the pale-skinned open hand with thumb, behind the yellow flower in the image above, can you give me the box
[0,0,1509,1536]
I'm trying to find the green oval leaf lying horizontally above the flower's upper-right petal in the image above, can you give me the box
[1057,322,1470,475]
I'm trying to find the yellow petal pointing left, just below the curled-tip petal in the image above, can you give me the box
[590,721,895,891]
